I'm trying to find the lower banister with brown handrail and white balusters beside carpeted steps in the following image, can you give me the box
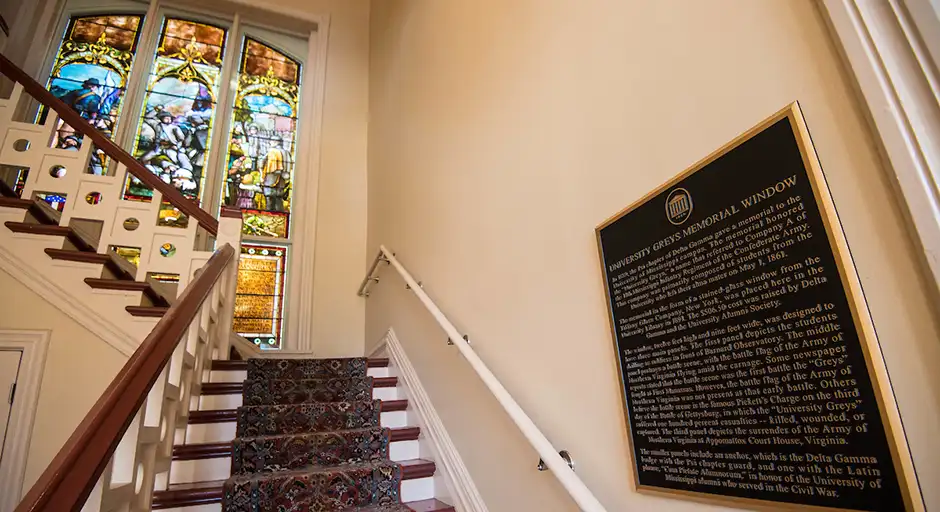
[15,244,236,512]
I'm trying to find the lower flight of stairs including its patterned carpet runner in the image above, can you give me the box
[153,358,455,512]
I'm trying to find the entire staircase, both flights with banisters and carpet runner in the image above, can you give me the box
[0,55,455,512]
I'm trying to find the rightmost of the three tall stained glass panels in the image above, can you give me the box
[222,37,300,238]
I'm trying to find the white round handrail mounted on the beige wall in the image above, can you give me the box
[360,245,606,512]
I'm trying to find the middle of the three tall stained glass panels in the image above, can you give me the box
[124,18,226,227]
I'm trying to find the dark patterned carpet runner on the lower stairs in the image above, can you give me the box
[222,358,411,512]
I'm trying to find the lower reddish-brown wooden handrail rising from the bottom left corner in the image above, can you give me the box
[15,244,235,512]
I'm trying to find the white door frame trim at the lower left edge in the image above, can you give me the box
[0,330,51,512]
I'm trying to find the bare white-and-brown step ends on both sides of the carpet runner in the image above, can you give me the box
[152,358,455,512]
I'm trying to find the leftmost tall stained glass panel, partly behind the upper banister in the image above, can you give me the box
[38,14,142,175]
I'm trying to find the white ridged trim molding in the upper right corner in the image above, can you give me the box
[818,0,940,287]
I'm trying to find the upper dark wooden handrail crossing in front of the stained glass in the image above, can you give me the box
[0,54,219,235]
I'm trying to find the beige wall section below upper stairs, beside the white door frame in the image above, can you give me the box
[0,271,127,492]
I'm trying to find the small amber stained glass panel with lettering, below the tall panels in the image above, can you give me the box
[232,244,287,348]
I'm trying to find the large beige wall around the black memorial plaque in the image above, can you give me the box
[366,0,940,511]
